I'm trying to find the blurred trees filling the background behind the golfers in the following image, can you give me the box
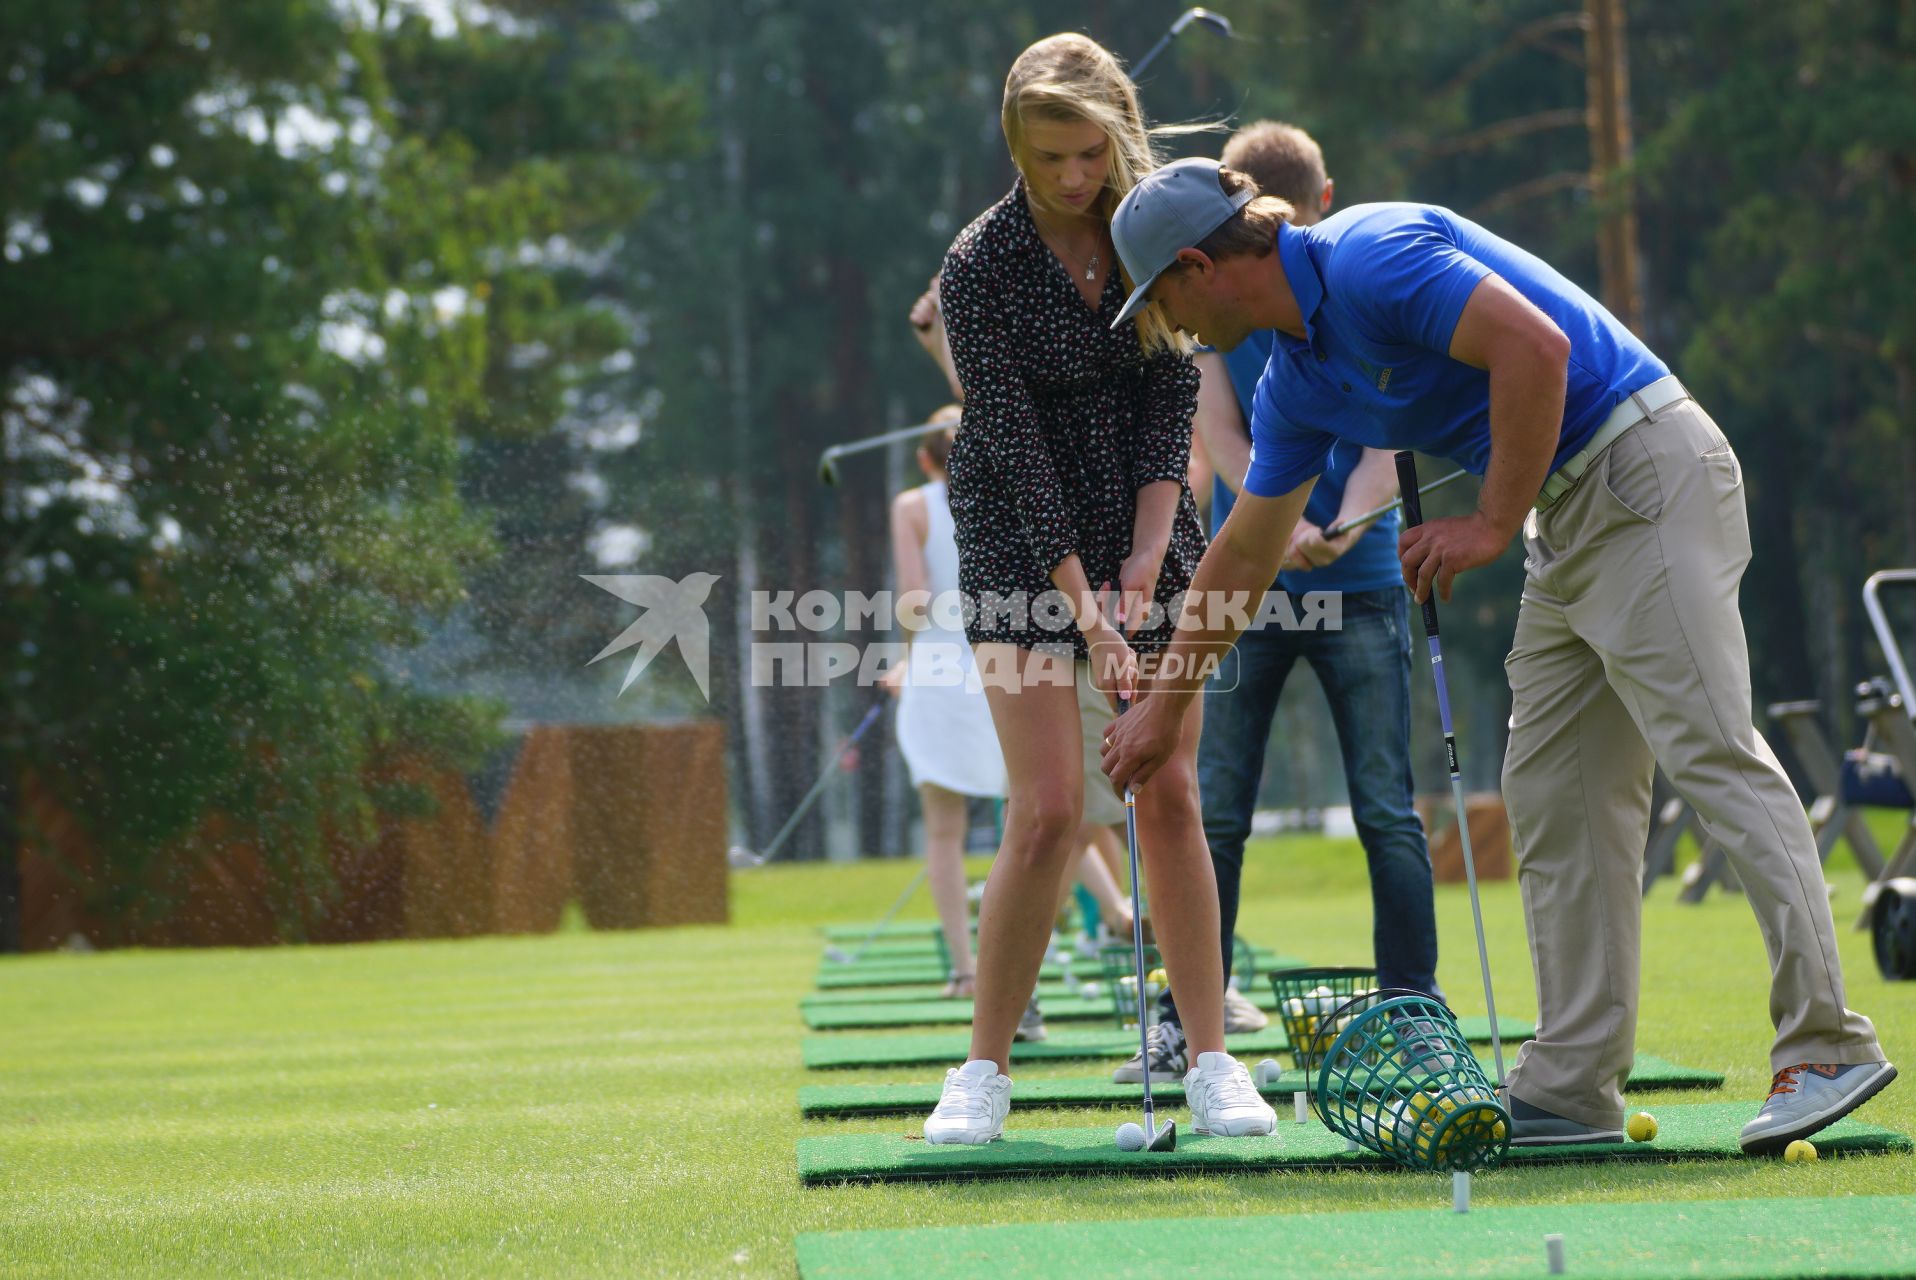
[0,0,1916,938]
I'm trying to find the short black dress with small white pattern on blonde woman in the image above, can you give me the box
[939,180,1205,659]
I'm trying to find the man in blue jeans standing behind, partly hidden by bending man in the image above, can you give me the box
[1111,121,1443,1083]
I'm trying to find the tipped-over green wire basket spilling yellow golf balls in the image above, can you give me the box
[1312,991,1510,1173]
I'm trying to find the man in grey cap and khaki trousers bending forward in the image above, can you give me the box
[1104,161,1895,1152]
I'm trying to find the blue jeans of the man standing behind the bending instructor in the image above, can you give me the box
[1167,586,1443,1014]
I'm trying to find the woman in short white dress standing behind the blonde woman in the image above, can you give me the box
[885,404,1130,996]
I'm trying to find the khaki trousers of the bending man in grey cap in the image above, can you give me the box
[1504,400,1883,1129]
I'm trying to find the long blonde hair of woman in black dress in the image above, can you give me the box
[998,31,1217,354]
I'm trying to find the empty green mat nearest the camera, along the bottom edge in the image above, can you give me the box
[797,1195,1916,1280]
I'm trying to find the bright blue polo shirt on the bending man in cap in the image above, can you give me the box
[1243,203,1669,498]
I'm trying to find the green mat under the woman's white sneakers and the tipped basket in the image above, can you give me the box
[799,1103,1916,1188]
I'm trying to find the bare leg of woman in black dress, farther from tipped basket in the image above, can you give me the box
[971,644,1088,1071]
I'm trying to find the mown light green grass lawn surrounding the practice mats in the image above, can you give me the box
[0,823,1916,1276]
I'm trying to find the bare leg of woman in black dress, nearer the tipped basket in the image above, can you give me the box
[1136,697,1224,1062]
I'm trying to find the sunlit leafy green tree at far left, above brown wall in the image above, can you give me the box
[0,0,689,933]
